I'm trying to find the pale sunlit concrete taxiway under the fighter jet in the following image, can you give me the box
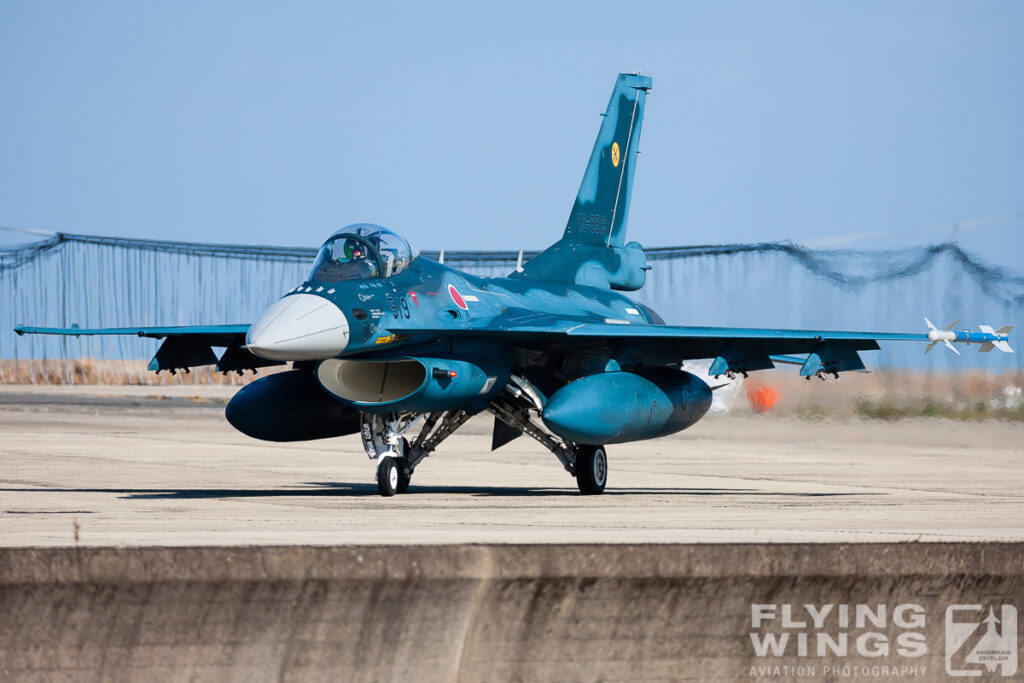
[0,386,1024,547]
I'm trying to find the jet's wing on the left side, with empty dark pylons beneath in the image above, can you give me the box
[14,325,283,374]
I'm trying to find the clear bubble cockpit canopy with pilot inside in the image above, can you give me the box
[309,223,413,283]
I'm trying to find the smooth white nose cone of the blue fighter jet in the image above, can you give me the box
[246,294,348,360]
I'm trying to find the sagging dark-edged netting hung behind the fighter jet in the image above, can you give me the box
[0,228,1024,381]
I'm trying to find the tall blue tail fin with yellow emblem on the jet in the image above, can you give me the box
[562,74,651,247]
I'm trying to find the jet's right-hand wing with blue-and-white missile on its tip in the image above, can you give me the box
[396,315,1009,376]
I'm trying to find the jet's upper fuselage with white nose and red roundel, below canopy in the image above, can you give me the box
[248,257,659,360]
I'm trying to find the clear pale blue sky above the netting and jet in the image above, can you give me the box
[0,0,1024,268]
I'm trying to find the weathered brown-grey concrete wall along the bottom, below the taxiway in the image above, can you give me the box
[0,544,1024,681]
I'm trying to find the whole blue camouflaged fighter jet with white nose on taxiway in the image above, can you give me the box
[15,74,1012,496]
